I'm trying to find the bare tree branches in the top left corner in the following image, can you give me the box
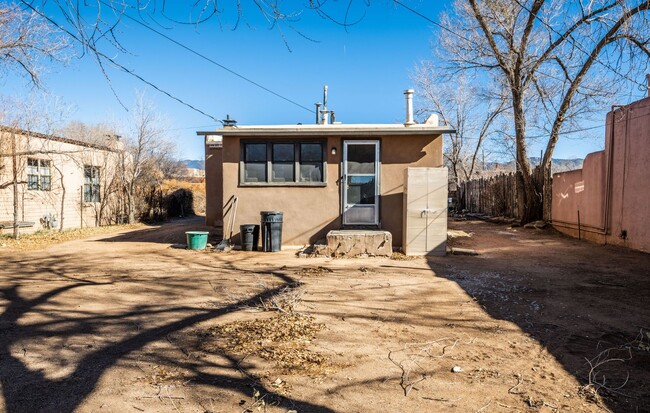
[0,3,69,86]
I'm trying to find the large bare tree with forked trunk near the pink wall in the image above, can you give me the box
[439,0,650,221]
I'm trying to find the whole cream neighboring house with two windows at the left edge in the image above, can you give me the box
[0,127,124,233]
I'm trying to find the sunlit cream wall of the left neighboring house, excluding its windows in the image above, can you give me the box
[0,131,120,233]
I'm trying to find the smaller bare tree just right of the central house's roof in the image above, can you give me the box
[413,69,507,182]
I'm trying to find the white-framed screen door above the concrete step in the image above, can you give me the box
[342,140,379,225]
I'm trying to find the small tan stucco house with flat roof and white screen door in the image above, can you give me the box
[197,91,453,251]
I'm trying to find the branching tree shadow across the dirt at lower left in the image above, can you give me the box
[0,254,331,413]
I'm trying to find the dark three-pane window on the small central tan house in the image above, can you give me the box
[240,140,325,185]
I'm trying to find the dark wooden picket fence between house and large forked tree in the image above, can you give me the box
[458,173,519,218]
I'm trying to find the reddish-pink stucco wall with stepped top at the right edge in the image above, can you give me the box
[552,97,650,252]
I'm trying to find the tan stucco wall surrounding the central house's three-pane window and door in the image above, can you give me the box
[215,135,442,246]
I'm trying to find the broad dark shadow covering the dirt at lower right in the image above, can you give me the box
[429,224,650,412]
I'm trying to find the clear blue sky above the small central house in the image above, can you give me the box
[2,0,616,159]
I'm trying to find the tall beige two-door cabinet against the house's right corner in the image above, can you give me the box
[402,168,448,255]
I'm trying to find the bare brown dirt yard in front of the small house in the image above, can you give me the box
[0,220,650,413]
